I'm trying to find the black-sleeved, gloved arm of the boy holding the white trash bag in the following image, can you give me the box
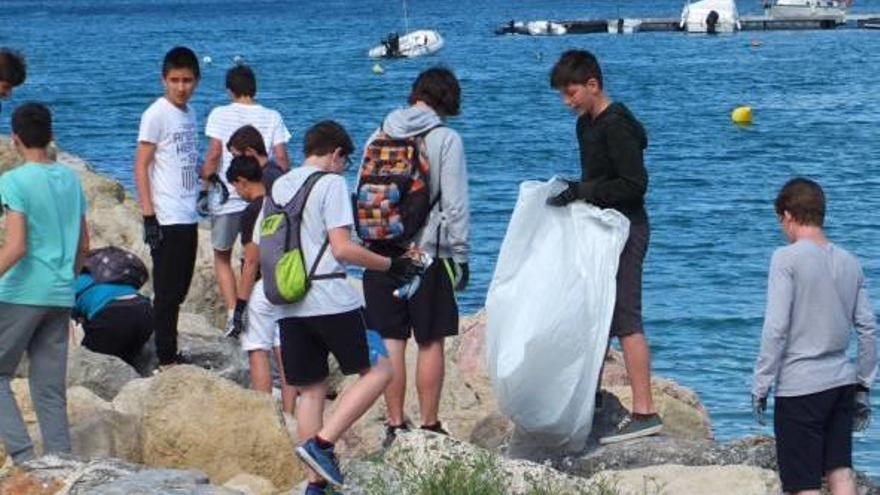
[578,126,648,208]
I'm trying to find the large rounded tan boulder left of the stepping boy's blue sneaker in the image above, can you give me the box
[141,365,304,487]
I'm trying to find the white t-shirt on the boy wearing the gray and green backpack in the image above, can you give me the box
[254,163,364,318]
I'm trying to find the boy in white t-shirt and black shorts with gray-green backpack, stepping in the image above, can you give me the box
[254,121,419,494]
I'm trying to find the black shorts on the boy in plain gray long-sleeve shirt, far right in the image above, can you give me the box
[773,385,855,492]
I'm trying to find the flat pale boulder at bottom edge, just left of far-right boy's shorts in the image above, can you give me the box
[592,464,782,495]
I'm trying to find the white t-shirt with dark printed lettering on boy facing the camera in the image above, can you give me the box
[138,97,199,225]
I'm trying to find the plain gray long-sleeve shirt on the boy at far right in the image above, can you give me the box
[752,240,877,397]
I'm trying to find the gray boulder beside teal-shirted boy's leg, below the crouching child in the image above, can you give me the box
[67,345,140,400]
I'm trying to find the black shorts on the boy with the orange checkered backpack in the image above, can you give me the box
[364,259,458,344]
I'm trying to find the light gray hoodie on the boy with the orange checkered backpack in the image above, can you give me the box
[358,105,470,263]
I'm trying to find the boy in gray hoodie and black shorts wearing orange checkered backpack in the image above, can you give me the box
[358,68,470,446]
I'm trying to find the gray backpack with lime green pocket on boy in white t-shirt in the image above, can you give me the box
[260,172,345,304]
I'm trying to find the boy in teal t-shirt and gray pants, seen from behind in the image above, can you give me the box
[0,103,88,463]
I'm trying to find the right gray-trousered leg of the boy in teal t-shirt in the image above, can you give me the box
[28,308,71,454]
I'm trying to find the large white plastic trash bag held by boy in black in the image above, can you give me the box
[486,178,629,451]
